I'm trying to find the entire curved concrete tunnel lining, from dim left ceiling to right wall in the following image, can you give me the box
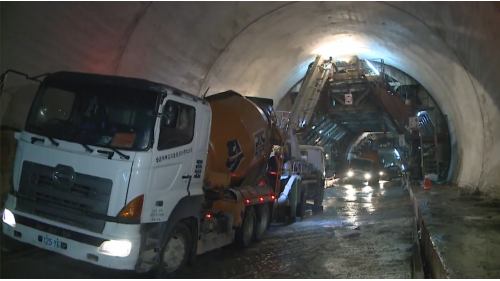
[0,2,500,196]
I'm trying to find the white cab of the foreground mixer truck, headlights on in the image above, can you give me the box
[3,72,211,271]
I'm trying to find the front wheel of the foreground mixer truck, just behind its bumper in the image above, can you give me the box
[156,222,192,279]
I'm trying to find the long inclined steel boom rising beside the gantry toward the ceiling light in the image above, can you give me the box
[290,55,331,130]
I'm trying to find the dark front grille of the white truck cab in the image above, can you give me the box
[16,161,113,233]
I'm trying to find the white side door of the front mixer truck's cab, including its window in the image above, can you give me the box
[141,95,199,222]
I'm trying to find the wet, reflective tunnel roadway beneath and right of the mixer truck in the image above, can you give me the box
[1,181,413,278]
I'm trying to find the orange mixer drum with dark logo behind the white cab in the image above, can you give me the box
[205,91,275,189]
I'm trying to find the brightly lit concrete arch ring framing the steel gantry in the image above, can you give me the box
[197,2,489,192]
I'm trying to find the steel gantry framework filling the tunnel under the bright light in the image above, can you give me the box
[277,56,453,186]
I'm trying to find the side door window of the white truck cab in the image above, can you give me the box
[158,101,196,150]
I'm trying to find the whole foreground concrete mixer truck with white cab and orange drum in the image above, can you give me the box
[3,72,286,276]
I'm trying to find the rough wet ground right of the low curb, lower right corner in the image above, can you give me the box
[412,186,500,279]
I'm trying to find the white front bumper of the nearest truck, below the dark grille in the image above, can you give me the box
[2,208,140,270]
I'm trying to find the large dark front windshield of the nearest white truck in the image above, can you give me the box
[26,84,158,150]
